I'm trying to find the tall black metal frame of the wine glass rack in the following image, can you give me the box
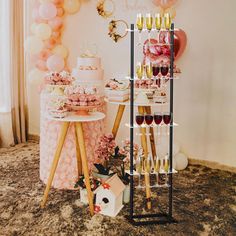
[128,23,176,225]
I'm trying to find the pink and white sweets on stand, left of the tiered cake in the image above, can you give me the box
[44,71,73,85]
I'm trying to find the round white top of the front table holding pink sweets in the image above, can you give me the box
[45,112,106,122]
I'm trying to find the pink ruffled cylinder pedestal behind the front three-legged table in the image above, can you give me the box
[40,92,105,189]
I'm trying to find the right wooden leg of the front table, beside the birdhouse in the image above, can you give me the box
[76,122,94,216]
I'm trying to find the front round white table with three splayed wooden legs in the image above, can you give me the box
[41,112,105,215]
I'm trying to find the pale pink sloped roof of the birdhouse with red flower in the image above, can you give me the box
[95,174,125,196]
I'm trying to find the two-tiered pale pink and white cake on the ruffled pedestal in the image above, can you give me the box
[72,56,104,86]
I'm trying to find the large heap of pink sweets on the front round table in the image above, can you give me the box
[65,85,101,106]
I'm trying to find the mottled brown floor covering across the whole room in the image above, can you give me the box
[0,142,236,236]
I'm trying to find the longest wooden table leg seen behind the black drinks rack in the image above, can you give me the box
[138,106,151,209]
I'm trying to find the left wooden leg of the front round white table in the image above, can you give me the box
[41,122,70,208]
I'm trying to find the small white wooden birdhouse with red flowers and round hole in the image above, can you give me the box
[94,174,125,217]
